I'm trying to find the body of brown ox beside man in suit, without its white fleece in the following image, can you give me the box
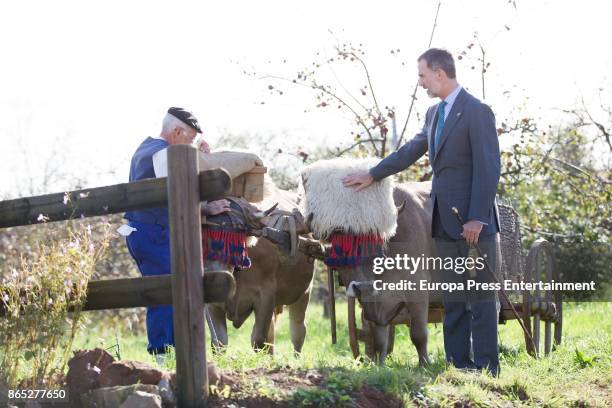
[339,183,434,365]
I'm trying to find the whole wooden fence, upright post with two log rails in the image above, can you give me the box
[0,145,235,407]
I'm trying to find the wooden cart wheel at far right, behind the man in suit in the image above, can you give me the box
[523,239,563,357]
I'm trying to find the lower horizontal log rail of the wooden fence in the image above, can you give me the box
[0,271,236,317]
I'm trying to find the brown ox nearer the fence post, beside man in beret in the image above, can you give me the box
[206,182,314,352]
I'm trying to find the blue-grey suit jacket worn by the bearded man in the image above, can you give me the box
[370,89,500,239]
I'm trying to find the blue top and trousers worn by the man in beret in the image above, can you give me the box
[125,137,174,354]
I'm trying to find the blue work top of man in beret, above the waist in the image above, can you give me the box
[125,137,169,227]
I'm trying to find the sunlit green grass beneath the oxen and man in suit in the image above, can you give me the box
[75,303,612,407]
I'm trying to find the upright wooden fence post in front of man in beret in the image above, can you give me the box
[168,145,208,407]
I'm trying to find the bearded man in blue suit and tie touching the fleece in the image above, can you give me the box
[343,48,500,375]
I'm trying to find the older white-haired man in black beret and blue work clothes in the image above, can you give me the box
[125,107,229,360]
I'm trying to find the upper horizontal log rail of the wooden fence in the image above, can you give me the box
[0,169,232,228]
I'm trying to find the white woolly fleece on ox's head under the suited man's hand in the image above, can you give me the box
[302,158,397,241]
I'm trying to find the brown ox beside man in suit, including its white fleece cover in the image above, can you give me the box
[302,159,434,365]
